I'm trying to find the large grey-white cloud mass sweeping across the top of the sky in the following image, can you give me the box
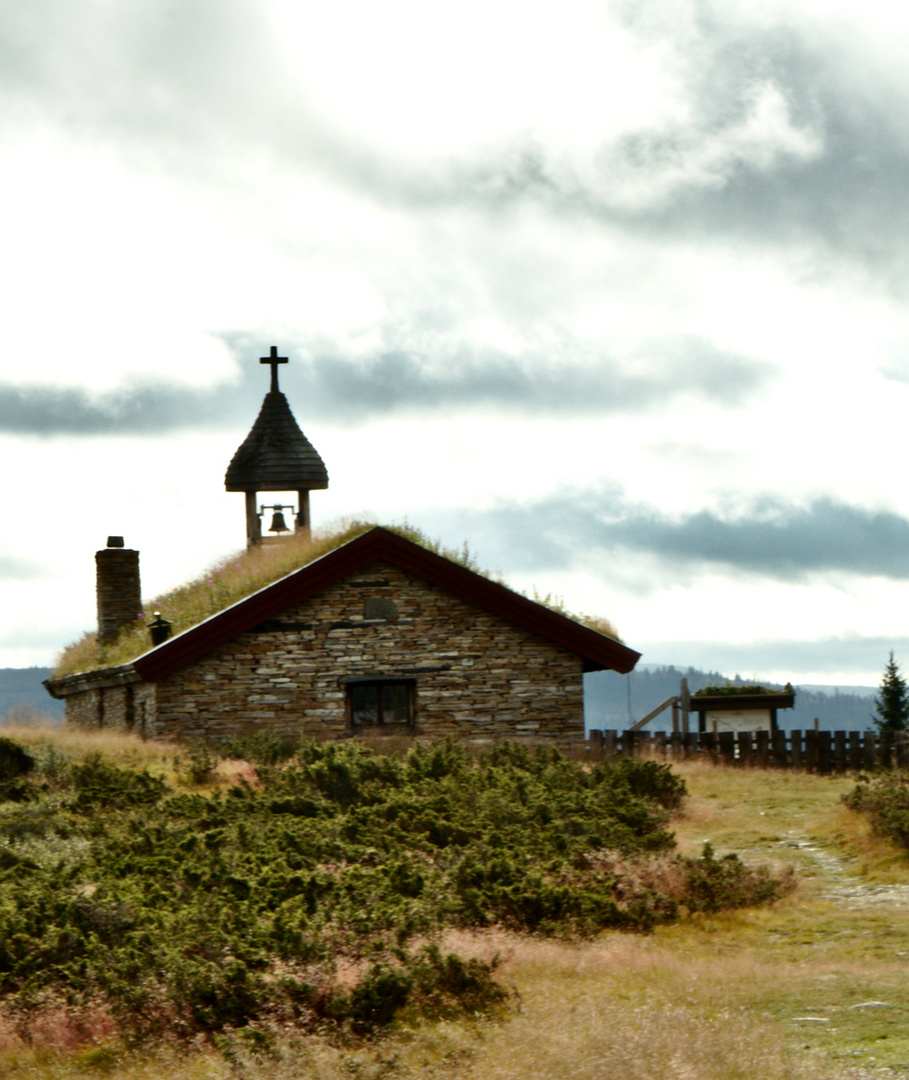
[0,0,909,291]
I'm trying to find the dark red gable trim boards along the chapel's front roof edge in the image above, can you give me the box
[133,527,640,683]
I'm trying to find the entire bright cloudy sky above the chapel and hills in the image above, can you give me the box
[0,0,909,685]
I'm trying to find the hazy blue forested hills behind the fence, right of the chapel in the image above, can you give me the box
[584,666,874,731]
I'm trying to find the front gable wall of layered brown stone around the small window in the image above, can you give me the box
[140,563,584,742]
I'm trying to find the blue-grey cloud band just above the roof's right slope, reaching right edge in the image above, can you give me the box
[424,488,909,581]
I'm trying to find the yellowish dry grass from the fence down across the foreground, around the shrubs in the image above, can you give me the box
[0,760,909,1080]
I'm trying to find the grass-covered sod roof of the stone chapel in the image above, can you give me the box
[52,521,620,678]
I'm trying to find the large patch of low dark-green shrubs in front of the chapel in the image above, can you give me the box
[0,740,790,1043]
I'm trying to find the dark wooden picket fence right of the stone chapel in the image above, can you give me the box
[586,730,909,772]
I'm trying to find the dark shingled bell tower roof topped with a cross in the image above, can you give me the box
[225,346,328,491]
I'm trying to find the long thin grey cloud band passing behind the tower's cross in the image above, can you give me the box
[0,336,772,436]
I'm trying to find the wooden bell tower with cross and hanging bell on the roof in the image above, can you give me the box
[225,346,328,545]
